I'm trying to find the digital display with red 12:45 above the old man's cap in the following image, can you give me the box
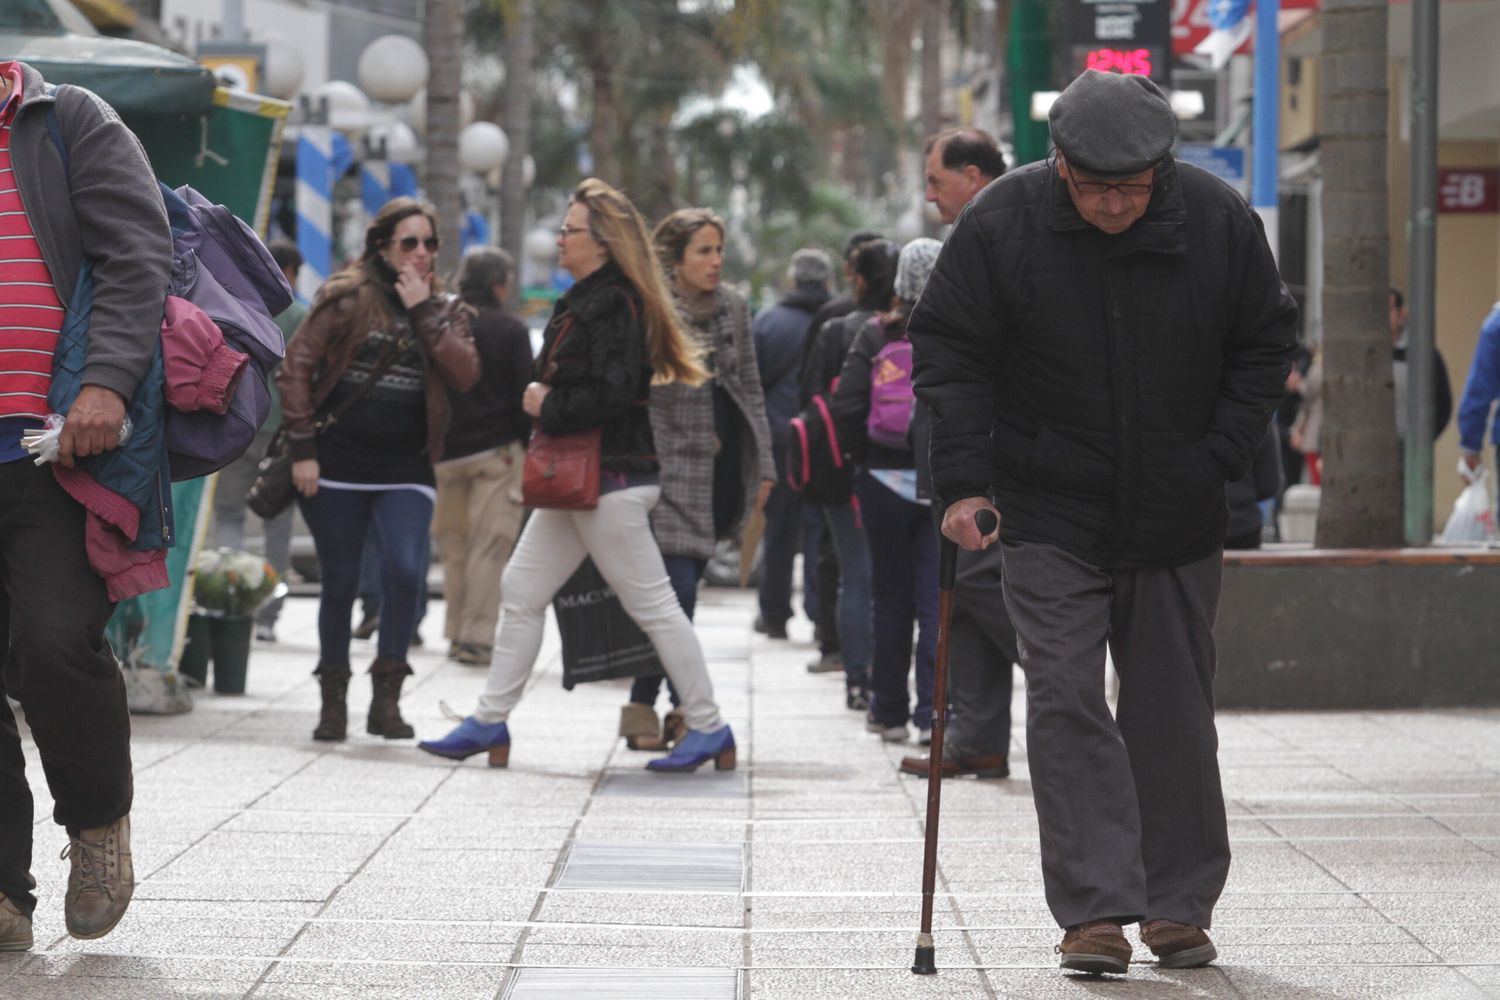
[1058,0,1172,85]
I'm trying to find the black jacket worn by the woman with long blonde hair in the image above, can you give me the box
[536,261,659,472]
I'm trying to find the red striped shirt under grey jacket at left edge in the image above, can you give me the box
[0,63,66,417]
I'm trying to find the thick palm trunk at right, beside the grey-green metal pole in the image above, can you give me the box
[1316,0,1404,549]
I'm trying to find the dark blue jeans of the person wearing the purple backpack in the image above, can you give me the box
[860,472,938,729]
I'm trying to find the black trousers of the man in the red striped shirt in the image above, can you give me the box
[0,459,134,915]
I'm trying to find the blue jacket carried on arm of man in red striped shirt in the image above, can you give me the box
[47,261,176,552]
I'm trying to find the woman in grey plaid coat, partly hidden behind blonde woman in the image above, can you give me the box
[620,208,776,750]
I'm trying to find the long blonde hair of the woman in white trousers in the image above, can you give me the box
[573,177,708,385]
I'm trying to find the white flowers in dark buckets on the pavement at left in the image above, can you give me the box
[177,549,285,694]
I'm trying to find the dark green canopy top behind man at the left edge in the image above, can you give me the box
[0,31,215,118]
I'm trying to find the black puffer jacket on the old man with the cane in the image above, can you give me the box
[911,152,1296,568]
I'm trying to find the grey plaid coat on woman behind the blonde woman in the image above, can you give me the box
[651,286,776,559]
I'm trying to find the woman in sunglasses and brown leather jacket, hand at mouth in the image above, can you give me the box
[278,198,480,741]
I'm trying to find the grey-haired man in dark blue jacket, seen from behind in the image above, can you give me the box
[750,247,834,637]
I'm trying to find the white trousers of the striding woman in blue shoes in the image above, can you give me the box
[474,486,723,732]
